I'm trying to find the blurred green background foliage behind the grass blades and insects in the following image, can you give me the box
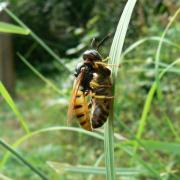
[0,0,180,180]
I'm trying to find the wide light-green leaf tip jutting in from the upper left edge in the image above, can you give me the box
[0,22,30,35]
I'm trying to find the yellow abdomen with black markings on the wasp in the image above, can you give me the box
[74,90,92,131]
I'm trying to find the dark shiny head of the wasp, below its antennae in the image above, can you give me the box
[83,49,102,61]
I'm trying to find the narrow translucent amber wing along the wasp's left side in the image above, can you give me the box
[67,71,84,124]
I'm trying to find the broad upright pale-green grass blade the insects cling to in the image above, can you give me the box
[104,0,136,180]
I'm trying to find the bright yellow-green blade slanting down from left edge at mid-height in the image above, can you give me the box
[0,81,30,133]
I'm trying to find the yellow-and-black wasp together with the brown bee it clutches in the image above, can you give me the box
[68,34,113,131]
